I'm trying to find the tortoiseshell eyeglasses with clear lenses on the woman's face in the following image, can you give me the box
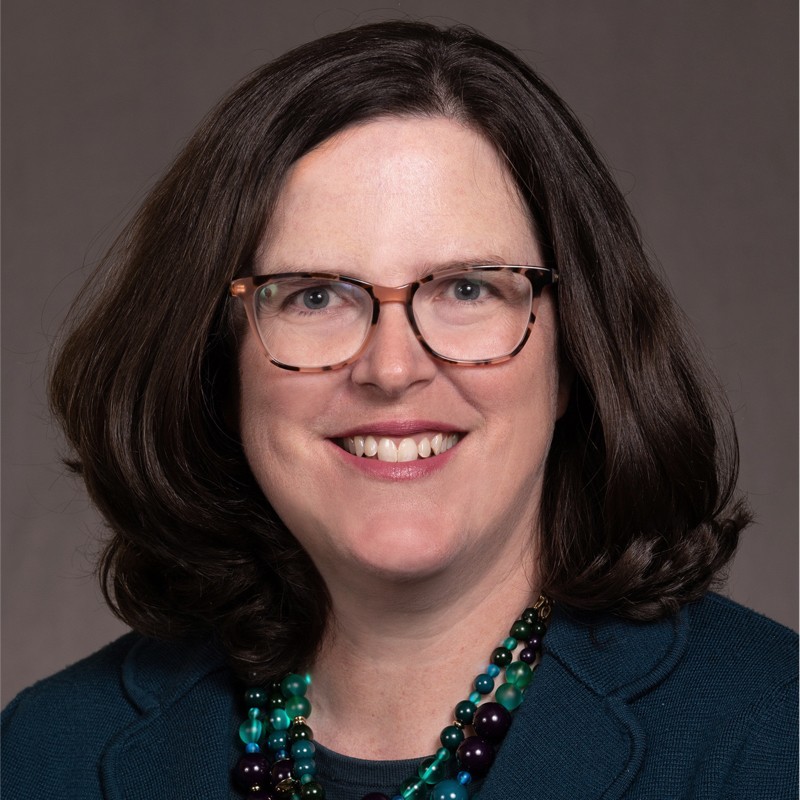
[230,266,558,372]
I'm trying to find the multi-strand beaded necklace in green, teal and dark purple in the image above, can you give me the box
[233,595,551,800]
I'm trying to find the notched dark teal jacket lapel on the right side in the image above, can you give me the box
[480,608,686,800]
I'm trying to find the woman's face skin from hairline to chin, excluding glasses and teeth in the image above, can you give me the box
[239,117,568,585]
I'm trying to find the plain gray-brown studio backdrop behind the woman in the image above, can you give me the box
[2,0,798,703]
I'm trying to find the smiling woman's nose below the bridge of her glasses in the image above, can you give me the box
[351,301,438,397]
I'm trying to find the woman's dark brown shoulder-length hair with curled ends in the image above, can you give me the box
[51,22,748,680]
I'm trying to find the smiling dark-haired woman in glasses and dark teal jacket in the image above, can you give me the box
[3,22,796,800]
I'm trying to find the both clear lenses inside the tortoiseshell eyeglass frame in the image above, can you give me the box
[254,269,532,368]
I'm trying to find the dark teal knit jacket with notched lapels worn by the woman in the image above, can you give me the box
[2,595,798,800]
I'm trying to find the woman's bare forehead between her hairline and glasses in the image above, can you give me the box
[257,117,539,283]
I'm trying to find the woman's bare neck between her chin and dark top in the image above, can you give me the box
[309,544,538,759]
